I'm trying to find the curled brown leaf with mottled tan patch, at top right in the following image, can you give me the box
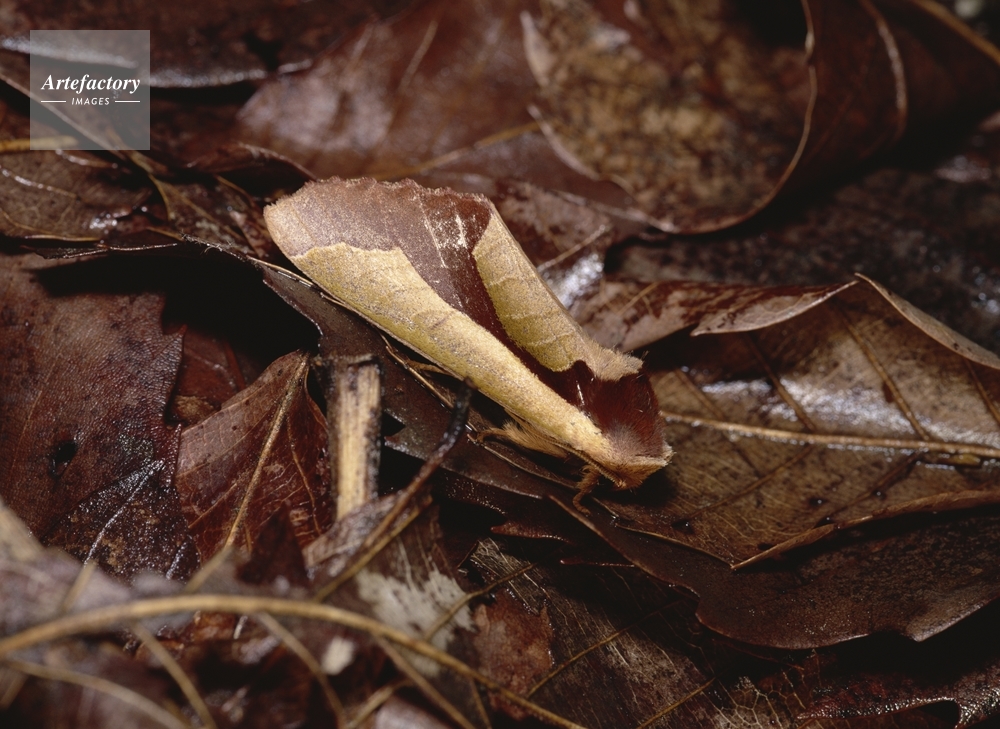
[525,0,1000,232]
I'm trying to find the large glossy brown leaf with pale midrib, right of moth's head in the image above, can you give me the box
[576,282,1000,565]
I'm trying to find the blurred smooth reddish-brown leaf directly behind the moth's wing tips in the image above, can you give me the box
[237,0,641,216]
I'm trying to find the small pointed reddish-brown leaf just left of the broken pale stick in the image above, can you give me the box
[176,353,333,559]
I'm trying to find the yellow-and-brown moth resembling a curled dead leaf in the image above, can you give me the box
[264,178,673,500]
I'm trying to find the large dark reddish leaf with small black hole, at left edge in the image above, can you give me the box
[0,255,197,578]
